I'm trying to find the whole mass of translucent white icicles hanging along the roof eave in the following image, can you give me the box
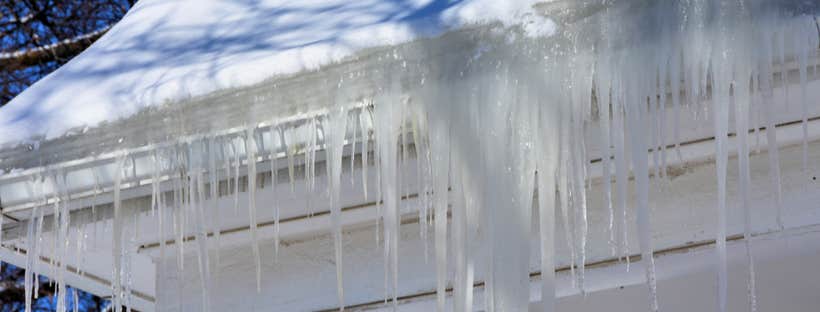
[8,1,818,311]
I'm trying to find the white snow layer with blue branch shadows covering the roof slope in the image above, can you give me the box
[0,0,550,144]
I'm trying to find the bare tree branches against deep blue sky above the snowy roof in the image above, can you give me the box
[0,0,136,105]
